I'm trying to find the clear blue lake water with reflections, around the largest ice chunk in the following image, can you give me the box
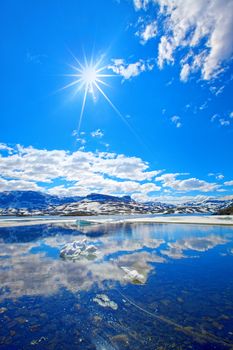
[0,223,233,350]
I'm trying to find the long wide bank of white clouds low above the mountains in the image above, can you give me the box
[0,144,227,201]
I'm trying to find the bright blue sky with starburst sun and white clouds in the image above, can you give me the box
[0,0,233,203]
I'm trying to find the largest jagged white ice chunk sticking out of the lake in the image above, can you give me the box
[60,239,97,260]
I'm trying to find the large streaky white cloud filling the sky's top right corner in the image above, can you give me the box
[134,0,233,81]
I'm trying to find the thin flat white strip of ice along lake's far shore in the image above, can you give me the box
[0,215,233,228]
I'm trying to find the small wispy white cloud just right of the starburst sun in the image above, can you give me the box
[108,58,154,80]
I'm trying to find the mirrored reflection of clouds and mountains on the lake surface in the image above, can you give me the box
[0,224,232,299]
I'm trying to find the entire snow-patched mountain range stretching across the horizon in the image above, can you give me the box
[0,191,233,216]
